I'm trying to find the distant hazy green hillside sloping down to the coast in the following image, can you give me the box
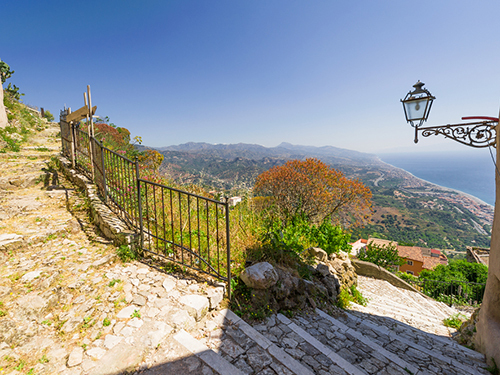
[146,142,493,251]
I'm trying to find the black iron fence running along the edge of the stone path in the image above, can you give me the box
[60,111,231,292]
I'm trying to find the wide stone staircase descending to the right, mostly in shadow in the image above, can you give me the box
[152,277,489,375]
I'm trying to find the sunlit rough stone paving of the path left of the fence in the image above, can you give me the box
[0,125,225,374]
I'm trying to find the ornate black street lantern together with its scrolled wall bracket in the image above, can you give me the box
[401,81,498,147]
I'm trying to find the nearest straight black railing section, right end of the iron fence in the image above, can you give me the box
[139,179,231,281]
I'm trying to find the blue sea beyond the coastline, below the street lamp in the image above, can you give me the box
[377,149,500,206]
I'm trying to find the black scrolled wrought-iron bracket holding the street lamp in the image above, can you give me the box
[415,119,498,148]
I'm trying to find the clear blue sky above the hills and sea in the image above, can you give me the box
[0,0,500,153]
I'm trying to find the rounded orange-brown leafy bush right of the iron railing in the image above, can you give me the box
[254,158,371,225]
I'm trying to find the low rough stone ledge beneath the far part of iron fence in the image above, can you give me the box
[56,155,140,251]
